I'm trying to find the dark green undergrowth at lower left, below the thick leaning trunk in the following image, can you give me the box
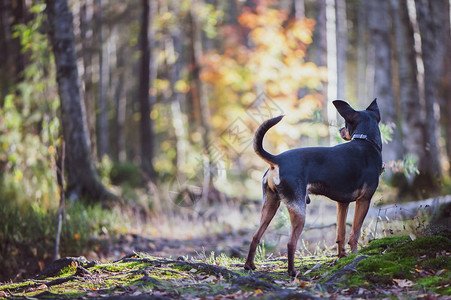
[0,198,126,282]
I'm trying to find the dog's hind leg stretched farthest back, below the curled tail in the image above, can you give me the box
[244,187,280,270]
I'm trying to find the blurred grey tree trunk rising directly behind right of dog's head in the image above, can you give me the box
[367,0,402,162]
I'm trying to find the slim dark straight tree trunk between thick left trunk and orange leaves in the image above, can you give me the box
[139,0,155,181]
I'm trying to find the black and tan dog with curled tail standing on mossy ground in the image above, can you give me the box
[244,100,382,276]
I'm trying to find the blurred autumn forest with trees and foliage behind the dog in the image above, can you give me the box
[0,0,451,281]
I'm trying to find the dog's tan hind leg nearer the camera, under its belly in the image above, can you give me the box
[287,202,305,276]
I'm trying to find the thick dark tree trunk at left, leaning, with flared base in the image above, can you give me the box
[46,0,114,202]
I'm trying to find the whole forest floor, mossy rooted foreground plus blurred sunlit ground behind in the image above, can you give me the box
[0,196,451,299]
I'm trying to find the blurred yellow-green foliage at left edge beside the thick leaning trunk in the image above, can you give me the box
[0,1,60,209]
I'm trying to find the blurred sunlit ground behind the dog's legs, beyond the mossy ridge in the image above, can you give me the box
[93,190,436,260]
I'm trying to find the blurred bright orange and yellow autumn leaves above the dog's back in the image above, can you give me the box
[201,1,327,117]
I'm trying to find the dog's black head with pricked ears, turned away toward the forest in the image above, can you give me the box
[333,99,381,141]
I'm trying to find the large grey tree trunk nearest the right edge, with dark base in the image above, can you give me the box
[415,0,449,189]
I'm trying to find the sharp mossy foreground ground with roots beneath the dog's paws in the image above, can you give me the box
[0,234,451,299]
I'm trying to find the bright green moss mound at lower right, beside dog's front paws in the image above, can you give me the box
[340,234,451,294]
